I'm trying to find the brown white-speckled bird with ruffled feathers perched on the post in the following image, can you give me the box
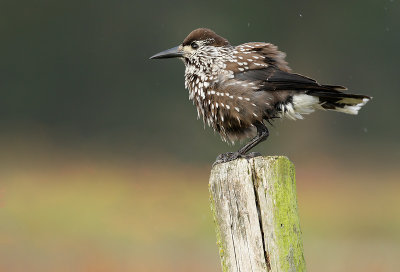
[150,28,372,164]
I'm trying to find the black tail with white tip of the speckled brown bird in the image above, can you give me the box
[307,85,372,114]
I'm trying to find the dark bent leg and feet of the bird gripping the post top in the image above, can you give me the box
[213,122,269,165]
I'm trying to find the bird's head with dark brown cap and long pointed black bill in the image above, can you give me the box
[150,28,230,64]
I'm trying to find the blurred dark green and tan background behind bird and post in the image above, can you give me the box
[0,0,400,272]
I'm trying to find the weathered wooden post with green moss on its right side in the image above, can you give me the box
[209,157,306,272]
